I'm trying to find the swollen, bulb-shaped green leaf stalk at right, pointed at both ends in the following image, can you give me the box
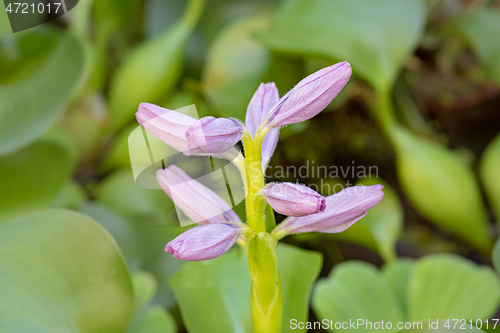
[393,128,492,252]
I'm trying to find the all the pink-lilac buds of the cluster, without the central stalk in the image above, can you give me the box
[137,62,384,260]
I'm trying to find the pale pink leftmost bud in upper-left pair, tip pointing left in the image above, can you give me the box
[139,103,196,152]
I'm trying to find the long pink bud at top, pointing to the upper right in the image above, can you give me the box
[263,62,352,127]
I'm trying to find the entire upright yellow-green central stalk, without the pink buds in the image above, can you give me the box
[242,132,283,333]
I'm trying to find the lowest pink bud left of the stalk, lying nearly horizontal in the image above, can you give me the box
[165,223,242,261]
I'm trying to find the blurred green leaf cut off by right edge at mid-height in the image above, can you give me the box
[479,135,500,223]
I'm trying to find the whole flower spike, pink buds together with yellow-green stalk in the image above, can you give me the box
[136,62,384,333]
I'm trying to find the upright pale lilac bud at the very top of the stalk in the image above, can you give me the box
[245,82,280,137]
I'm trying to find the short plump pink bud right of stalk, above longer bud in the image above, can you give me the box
[262,183,326,216]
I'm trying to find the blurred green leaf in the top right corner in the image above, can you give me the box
[447,7,500,83]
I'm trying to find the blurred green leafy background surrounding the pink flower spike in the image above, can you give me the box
[0,0,500,333]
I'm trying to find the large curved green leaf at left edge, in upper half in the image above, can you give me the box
[0,34,84,155]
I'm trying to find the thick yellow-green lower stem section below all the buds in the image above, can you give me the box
[246,232,283,333]
